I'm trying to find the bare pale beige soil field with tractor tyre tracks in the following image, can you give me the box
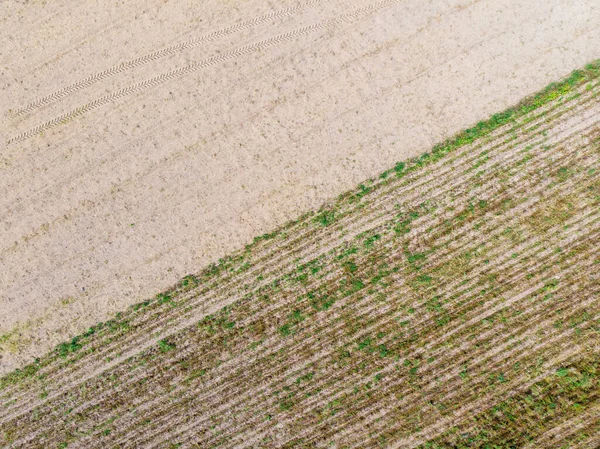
[0,0,600,372]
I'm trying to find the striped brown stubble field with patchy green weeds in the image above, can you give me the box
[0,61,600,449]
